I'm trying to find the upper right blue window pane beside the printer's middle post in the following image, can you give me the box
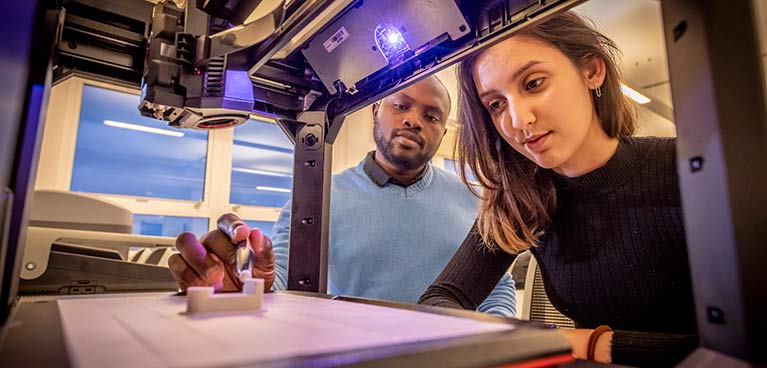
[229,120,293,207]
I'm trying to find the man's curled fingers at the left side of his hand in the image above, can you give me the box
[177,232,224,289]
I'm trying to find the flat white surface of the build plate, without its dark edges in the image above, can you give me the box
[58,293,514,368]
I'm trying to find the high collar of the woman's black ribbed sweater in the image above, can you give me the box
[552,137,649,193]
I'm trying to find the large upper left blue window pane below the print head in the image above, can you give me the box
[71,85,208,201]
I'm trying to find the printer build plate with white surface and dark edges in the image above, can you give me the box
[0,292,572,367]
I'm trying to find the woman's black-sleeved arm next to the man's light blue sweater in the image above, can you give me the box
[418,224,516,310]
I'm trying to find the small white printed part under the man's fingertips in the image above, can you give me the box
[186,279,264,314]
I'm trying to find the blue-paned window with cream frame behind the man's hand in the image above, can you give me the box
[35,76,304,237]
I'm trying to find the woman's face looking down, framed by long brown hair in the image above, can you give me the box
[474,36,609,174]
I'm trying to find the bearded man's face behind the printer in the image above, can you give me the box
[373,78,450,170]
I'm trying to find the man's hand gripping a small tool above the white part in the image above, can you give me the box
[168,213,274,292]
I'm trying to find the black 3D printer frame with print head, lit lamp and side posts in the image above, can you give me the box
[0,0,767,364]
